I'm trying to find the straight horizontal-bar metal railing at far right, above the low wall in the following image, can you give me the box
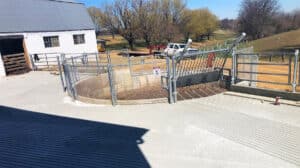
[232,50,300,92]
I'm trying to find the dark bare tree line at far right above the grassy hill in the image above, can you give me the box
[220,0,300,40]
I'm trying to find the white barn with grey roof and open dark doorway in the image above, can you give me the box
[0,0,97,76]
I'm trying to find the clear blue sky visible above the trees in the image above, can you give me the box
[77,0,300,19]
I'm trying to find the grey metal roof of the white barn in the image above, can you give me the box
[0,0,95,33]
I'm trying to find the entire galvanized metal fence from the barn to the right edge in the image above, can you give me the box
[30,34,300,105]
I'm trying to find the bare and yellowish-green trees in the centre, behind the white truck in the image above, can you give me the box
[88,0,219,49]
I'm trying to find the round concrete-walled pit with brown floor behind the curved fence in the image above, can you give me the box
[76,69,168,104]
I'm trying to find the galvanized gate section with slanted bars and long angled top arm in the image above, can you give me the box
[161,33,246,103]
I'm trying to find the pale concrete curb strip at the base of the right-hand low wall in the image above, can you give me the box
[224,92,300,107]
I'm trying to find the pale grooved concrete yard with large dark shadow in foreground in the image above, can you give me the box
[0,72,300,168]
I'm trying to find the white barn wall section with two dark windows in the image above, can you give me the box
[24,30,97,54]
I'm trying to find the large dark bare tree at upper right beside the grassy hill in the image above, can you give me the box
[238,0,280,39]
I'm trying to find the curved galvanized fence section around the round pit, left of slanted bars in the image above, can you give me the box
[57,51,171,105]
